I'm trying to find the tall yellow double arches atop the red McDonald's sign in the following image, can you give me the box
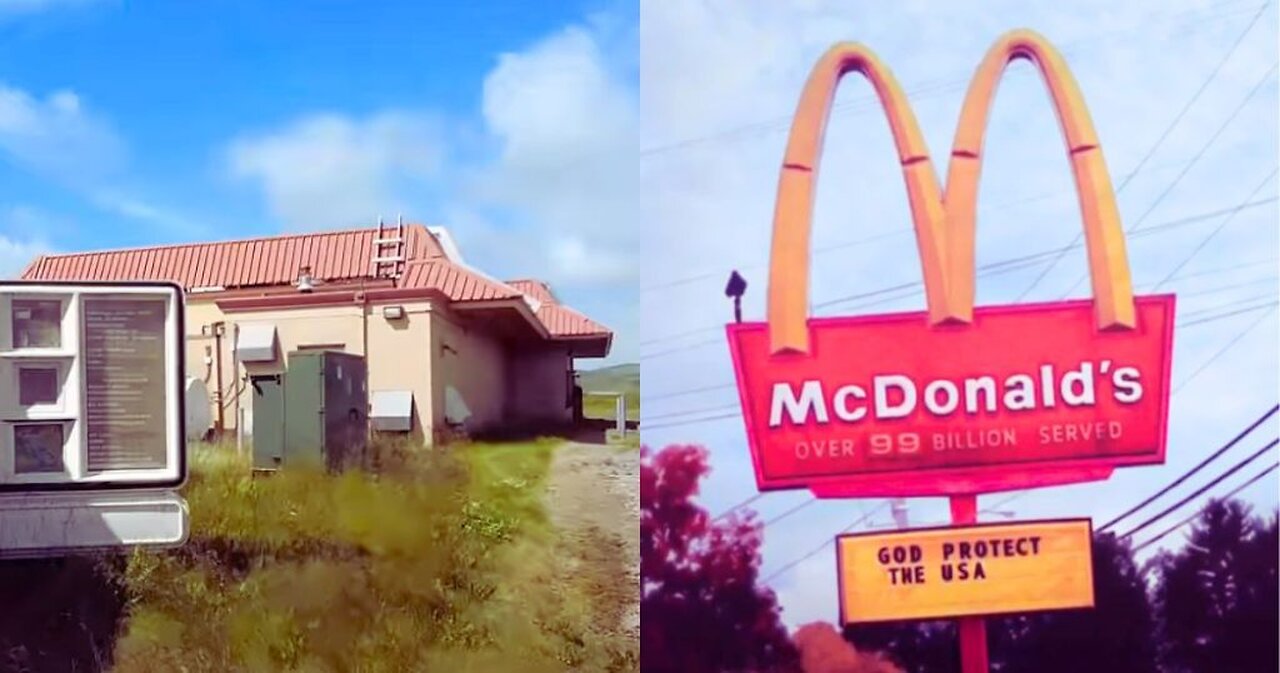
[768,31,1134,353]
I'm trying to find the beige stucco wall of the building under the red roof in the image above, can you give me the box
[186,296,586,441]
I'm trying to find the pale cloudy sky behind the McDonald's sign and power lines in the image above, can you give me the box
[640,0,1280,634]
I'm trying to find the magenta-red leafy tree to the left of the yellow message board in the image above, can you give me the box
[640,445,799,673]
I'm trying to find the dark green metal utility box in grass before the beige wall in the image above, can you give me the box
[285,351,369,471]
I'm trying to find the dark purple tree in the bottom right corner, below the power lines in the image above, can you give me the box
[1153,500,1280,673]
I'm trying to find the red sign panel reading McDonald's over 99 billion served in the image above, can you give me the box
[728,294,1174,496]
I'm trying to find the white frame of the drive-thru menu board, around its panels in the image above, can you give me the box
[0,280,187,493]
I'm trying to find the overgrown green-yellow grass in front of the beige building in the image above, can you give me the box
[107,440,637,673]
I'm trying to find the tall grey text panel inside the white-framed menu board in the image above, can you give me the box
[83,297,166,472]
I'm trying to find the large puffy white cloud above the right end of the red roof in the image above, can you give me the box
[472,21,640,284]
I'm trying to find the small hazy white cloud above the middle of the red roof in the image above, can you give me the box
[228,111,444,229]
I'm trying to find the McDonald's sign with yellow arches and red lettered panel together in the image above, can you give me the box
[727,31,1174,496]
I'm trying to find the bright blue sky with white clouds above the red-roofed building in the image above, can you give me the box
[0,0,639,361]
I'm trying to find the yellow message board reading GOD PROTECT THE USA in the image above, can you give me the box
[836,519,1093,624]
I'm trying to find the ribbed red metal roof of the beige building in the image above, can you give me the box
[22,224,612,337]
